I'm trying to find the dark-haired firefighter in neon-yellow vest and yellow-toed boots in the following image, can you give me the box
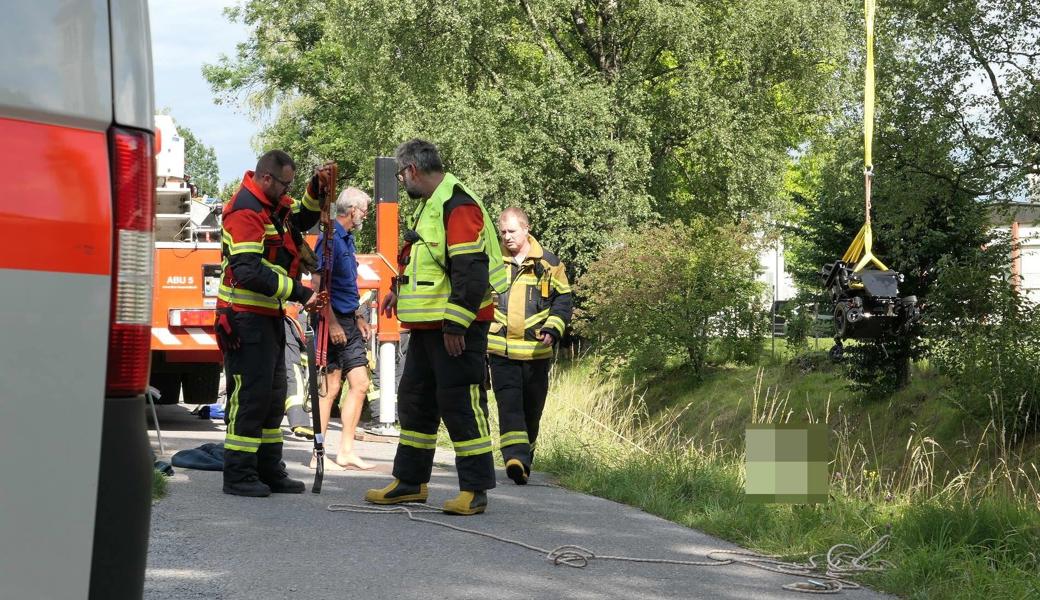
[365,139,505,515]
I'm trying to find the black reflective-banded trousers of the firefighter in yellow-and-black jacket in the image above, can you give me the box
[489,355,552,470]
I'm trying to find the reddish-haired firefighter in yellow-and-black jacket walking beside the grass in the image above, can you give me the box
[488,208,573,486]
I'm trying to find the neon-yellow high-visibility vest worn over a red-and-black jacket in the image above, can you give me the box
[397,173,505,328]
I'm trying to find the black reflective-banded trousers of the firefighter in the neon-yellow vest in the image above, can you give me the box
[393,322,495,491]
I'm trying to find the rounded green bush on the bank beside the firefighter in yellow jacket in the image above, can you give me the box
[577,218,769,372]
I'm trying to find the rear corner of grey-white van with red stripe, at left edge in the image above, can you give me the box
[0,0,154,599]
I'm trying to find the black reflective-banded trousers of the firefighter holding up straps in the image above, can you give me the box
[224,312,286,480]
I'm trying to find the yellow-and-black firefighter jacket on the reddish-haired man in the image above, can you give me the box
[488,235,573,361]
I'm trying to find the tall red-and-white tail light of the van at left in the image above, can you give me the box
[105,127,155,396]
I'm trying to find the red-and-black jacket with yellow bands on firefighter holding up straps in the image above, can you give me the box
[216,171,321,316]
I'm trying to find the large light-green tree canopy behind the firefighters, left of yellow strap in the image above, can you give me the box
[204,0,849,271]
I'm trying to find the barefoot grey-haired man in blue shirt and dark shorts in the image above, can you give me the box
[311,187,373,469]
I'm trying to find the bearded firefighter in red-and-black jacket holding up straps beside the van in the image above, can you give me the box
[215,150,331,497]
